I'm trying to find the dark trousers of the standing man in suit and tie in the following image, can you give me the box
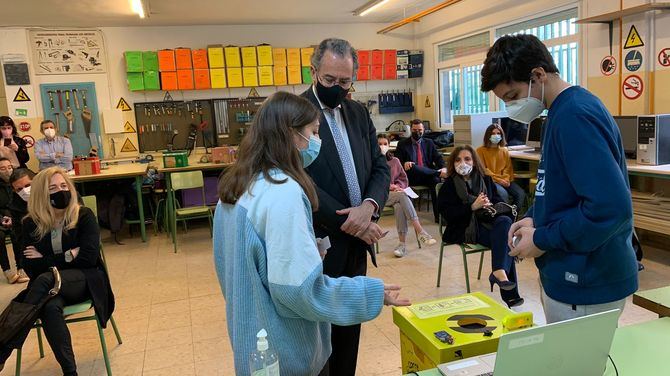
[328,249,368,376]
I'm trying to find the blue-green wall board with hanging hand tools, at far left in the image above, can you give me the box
[40,82,104,159]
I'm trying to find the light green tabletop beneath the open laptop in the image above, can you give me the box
[411,317,670,376]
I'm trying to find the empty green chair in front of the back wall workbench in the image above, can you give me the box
[169,171,213,253]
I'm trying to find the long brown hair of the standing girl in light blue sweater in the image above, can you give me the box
[218,91,319,210]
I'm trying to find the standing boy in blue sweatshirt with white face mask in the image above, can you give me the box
[481,35,638,323]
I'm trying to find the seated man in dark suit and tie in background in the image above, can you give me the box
[395,119,447,222]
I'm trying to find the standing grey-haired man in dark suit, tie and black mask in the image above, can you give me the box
[302,39,390,375]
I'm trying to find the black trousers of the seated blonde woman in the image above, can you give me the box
[0,269,89,376]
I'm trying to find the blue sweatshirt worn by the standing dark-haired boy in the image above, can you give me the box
[529,86,638,305]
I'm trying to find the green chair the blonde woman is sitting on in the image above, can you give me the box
[16,196,123,376]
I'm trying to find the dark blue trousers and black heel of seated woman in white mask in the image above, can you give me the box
[478,215,520,301]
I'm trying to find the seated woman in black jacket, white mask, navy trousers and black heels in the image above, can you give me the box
[437,145,523,307]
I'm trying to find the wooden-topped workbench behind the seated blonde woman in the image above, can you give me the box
[71,163,149,242]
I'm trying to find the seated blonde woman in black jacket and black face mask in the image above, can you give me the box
[0,167,114,376]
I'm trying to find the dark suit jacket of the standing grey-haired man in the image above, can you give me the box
[302,87,390,277]
